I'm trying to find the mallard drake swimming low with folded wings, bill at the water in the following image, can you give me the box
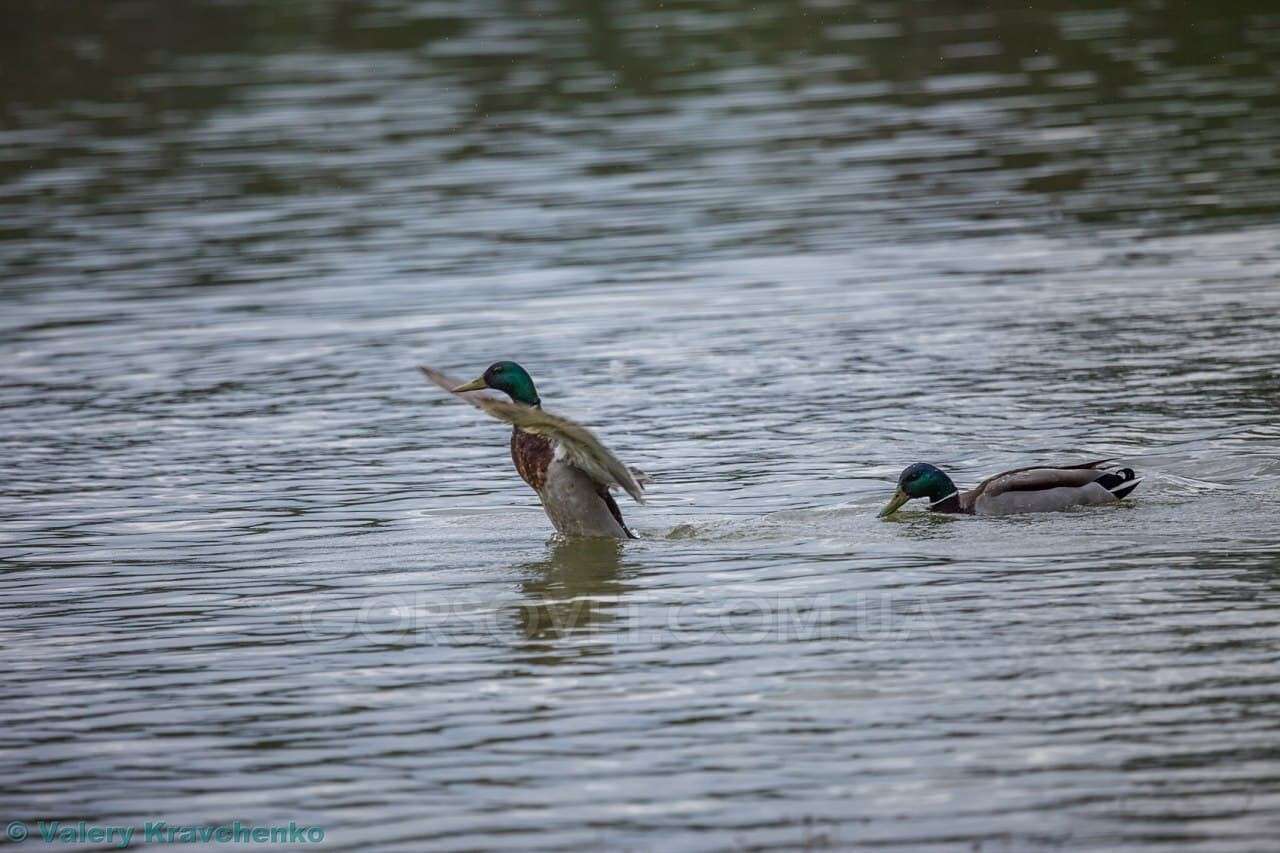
[881,459,1142,519]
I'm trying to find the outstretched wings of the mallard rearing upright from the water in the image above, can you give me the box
[420,368,644,503]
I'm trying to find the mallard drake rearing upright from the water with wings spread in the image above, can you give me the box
[421,361,646,539]
